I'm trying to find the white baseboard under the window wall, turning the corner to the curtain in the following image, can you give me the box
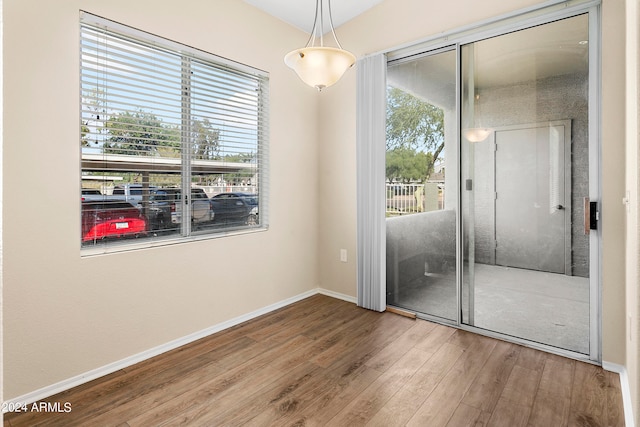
[1,288,330,407]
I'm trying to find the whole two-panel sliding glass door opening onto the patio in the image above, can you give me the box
[385,9,600,360]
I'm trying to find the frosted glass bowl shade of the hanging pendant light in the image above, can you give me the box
[284,46,356,91]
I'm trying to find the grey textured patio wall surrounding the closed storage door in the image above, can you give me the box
[474,76,589,277]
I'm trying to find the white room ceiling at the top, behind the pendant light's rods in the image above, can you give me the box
[244,0,383,34]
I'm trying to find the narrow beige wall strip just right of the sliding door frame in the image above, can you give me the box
[602,0,628,372]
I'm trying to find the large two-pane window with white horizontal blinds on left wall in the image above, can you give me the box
[80,13,268,254]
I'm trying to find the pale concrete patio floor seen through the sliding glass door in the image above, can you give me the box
[387,264,589,354]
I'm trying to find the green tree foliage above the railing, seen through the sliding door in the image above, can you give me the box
[386,87,444,182]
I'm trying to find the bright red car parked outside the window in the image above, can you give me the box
[82,200,147,243]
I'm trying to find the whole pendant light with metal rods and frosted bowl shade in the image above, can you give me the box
[284,0,356,91]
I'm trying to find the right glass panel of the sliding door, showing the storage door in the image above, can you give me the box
[461,15,590,354]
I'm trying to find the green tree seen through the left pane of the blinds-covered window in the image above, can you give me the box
[104,110,180,156]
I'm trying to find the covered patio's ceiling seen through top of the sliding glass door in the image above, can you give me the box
[387,15,589,109]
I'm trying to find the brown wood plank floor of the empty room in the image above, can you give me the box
[4,295,624,427]
